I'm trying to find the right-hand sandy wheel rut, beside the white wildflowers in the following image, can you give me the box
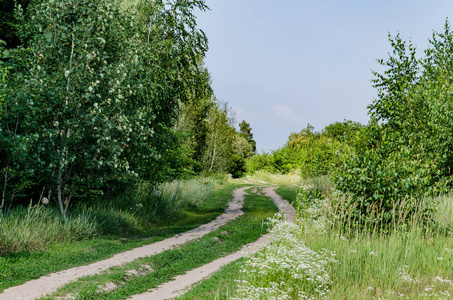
[129,186,296,300]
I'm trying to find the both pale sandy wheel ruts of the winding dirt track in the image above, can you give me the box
[0,187,295,300]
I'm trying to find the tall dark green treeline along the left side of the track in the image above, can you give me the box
[0,0,254,216]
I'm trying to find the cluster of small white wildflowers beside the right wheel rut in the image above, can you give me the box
[233,219,337,299]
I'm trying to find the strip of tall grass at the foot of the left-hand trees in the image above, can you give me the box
[0,178,217,255]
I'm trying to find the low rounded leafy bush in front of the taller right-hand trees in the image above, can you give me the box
[333,151,442,230]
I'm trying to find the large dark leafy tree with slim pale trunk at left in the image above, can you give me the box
[0,0,207,217]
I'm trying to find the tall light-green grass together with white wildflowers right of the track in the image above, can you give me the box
[236,180,453,299]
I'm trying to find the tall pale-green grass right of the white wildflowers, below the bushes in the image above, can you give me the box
[300,185,453,299]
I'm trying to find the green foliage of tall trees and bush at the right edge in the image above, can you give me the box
[334,22,453,227]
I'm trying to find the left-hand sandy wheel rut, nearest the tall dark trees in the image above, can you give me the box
[0,187,251,300]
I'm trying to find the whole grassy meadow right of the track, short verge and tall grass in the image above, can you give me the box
[178,179,453,299]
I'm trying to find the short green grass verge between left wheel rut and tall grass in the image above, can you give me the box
[0,185,242,291]
